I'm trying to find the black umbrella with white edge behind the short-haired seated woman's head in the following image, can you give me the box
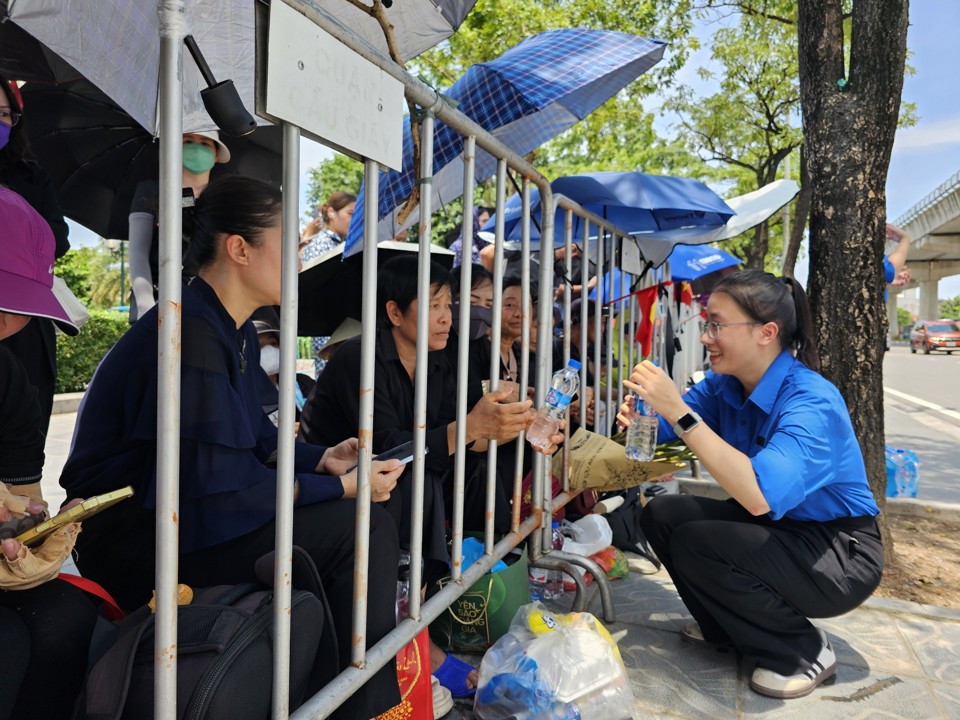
[297,240,454,336]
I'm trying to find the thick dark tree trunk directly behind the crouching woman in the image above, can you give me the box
[798,0,908,560]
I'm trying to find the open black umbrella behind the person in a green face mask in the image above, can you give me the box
[21,78,283,239]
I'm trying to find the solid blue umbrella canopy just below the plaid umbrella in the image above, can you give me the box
[484,172,736,245]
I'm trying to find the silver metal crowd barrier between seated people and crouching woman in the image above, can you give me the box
[155,0,656,718]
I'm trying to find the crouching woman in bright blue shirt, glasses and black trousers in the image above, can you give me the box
[619,270,883,698]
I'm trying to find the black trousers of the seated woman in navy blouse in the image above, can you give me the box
[77,500,401,720]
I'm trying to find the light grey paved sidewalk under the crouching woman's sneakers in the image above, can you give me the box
[43,413,960,720]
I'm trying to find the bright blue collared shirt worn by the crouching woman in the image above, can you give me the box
[660,351,880,522]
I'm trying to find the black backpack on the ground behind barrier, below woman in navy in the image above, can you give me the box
[80,547,338,720]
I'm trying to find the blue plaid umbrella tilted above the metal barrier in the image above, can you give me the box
[345,29,666,256]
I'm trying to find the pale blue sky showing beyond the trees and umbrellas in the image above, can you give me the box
[71,0,960,297]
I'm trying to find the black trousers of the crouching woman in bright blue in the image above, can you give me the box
[640,495,883,675]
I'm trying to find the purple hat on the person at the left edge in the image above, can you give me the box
[0,187,80,335]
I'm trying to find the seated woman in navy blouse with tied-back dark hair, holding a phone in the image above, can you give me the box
[60,176,403,718]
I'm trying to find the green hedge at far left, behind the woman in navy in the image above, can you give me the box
[55,310,129,393]
